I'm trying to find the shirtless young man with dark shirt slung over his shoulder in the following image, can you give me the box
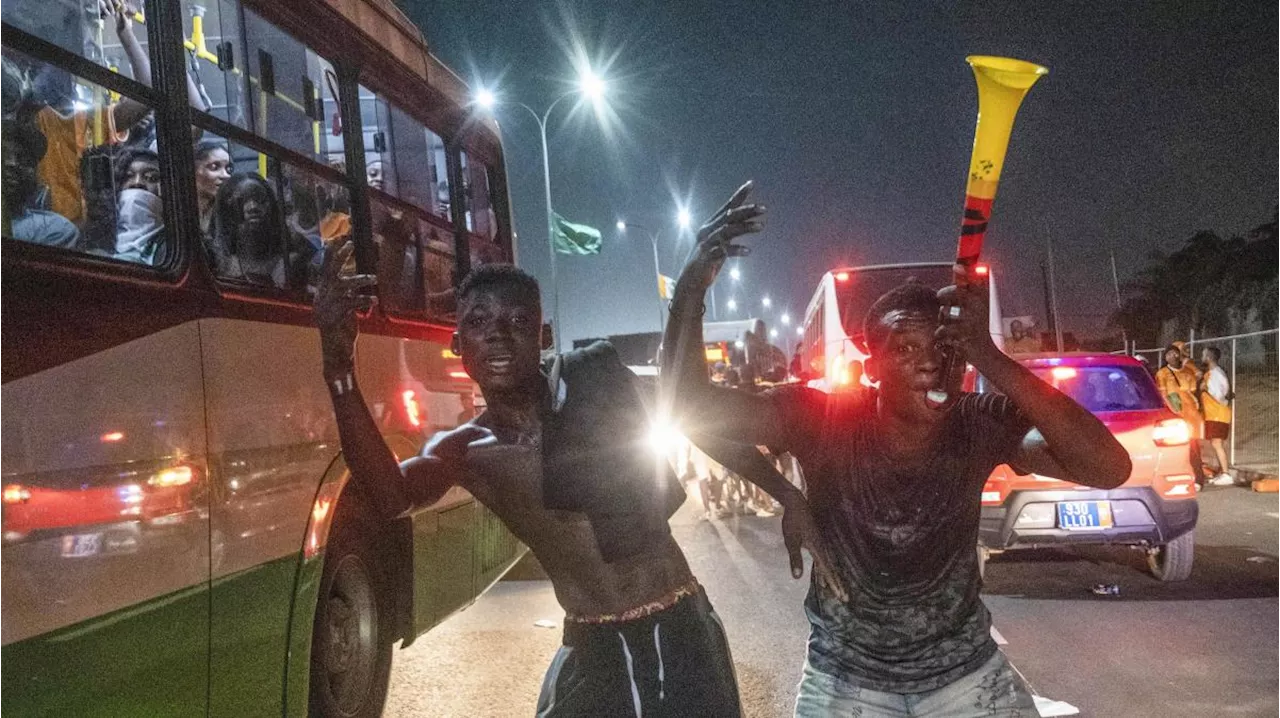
[315,234,834,718]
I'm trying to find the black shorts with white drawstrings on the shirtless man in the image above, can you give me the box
[538,590,742,718]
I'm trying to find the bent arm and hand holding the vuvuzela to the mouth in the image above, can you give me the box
[938,271,1133,489]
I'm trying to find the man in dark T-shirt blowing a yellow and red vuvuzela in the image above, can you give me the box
[666,183,1130,718]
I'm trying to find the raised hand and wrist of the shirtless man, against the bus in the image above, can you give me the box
[315,237,378,376]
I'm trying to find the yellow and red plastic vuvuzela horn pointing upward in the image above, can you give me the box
[925,55,1048,408]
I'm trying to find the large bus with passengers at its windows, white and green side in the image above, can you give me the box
[0,0,524,717]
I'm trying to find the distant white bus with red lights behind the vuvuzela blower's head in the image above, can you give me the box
[800,262,1005,393]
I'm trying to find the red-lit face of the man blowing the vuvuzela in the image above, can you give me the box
[867,312,942,394]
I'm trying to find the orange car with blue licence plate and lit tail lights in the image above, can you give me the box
[978,353,1199,581]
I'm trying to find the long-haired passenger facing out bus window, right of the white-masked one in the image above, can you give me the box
[209,173,315,288]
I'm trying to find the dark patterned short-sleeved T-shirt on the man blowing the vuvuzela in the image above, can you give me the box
[765,387,1030,694]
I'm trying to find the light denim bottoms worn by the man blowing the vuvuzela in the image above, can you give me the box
[796,651,1039,718]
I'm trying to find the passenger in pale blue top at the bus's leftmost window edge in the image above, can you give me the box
[0,106,79,250]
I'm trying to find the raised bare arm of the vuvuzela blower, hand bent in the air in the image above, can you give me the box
[662,182,781,442]
